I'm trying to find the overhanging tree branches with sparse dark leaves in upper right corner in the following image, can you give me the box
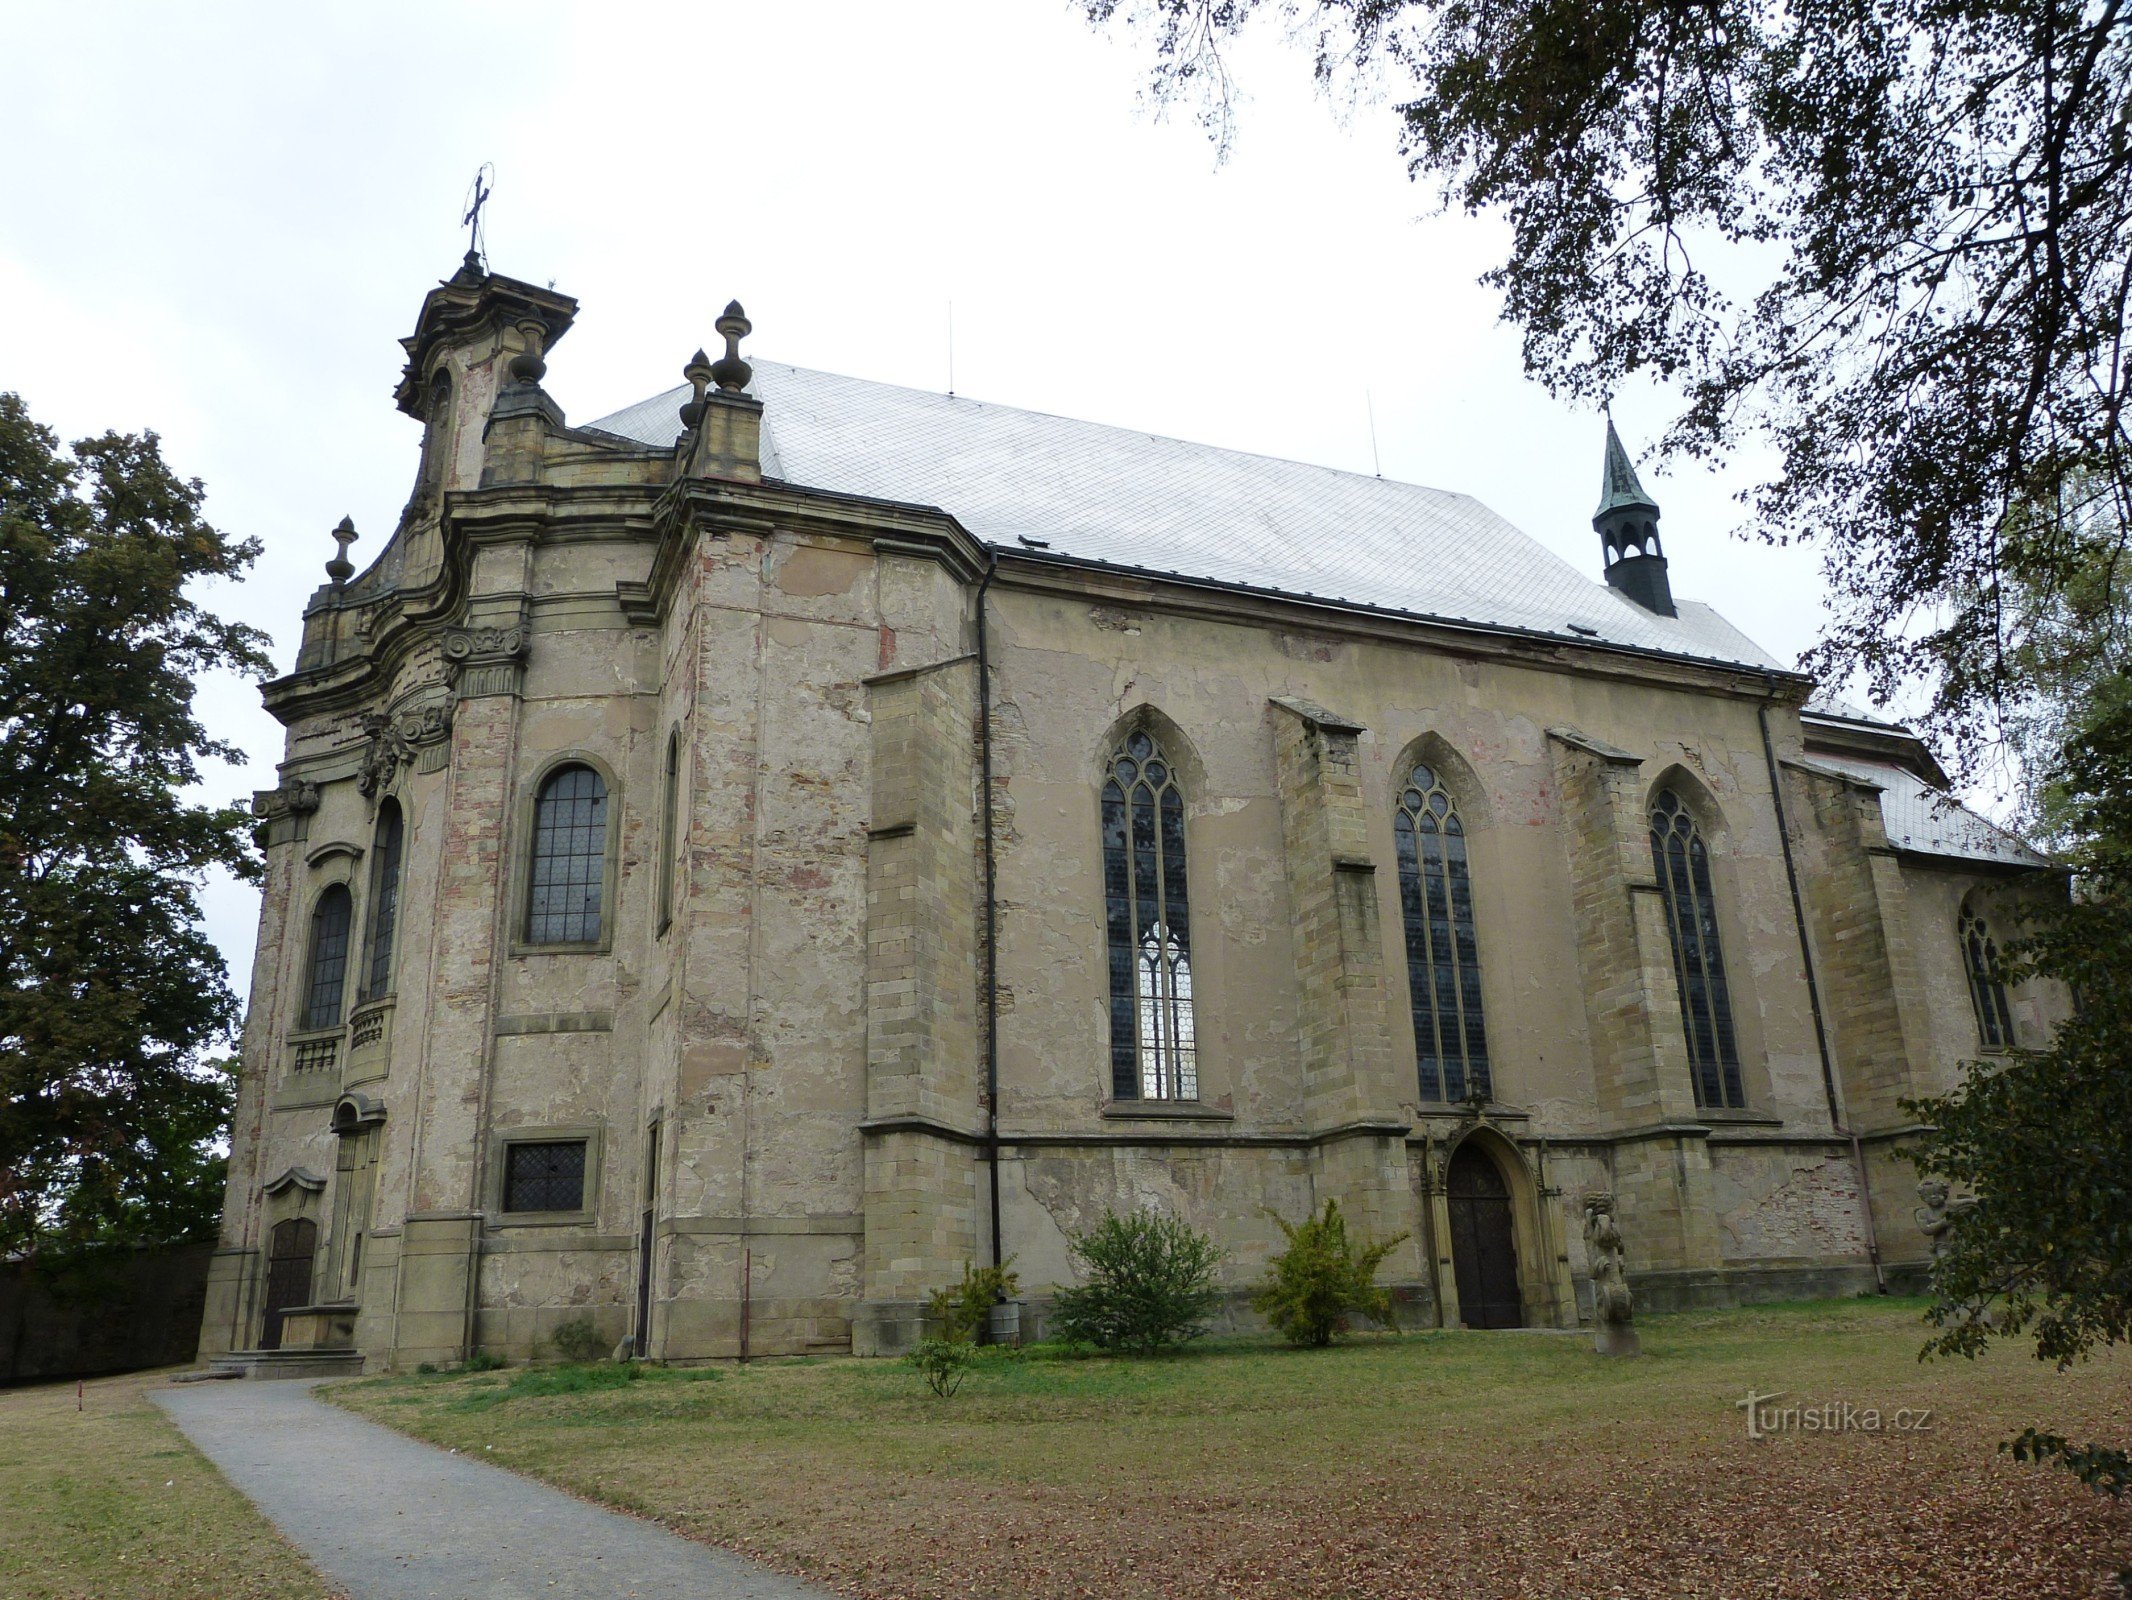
[1081,0,2132,755]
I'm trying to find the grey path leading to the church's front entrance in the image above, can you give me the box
[156,1380,827,1600]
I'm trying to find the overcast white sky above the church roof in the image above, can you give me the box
[0,0,1823,992]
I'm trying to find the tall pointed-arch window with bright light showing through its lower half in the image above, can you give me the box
[1102,734,1198,1101]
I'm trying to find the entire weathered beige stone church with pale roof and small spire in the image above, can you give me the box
[203,258,2057,1370]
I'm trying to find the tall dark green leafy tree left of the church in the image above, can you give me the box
[0,395,267,1257]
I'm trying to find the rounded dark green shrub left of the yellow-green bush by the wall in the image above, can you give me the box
[1051,1212,1222,1355]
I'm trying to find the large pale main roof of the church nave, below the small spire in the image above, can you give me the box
[591,361,1784,670]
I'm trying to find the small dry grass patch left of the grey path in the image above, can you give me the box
[0,1372,337,1600]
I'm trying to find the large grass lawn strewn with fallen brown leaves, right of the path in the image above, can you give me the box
[330,1301,2132,1600]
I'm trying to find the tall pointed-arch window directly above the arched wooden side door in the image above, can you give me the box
[1392,764,1492,1101]
